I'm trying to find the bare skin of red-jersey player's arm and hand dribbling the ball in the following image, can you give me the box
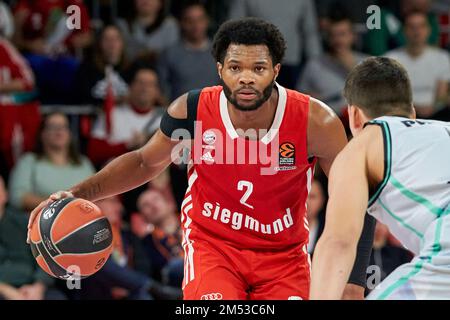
[28,94,187,241]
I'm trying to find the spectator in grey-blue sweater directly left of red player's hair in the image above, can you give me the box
[159,2,219,100]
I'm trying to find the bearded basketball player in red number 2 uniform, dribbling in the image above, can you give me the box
[26,18,371,300]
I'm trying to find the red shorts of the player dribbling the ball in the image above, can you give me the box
[183,235,310,300]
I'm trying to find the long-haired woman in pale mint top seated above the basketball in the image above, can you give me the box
[9,113,94,212]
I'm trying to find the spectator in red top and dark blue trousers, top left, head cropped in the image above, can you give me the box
[14,0,91,104]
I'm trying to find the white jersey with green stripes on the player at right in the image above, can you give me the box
[368,117,450,299]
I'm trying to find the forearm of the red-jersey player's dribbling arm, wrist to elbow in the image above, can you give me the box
[70,151,162,201]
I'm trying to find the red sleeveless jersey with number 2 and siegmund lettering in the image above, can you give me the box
[181,85,315,255]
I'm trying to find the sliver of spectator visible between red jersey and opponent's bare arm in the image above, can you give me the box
[306,178,326,255]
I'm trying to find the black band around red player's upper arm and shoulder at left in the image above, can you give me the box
[160,90,201,139]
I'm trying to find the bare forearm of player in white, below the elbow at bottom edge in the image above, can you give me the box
[310,237,356,300]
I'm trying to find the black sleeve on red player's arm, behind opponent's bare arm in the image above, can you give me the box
[348,213,376,288]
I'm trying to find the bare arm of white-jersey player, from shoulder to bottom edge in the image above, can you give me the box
[310,126,383,299]
